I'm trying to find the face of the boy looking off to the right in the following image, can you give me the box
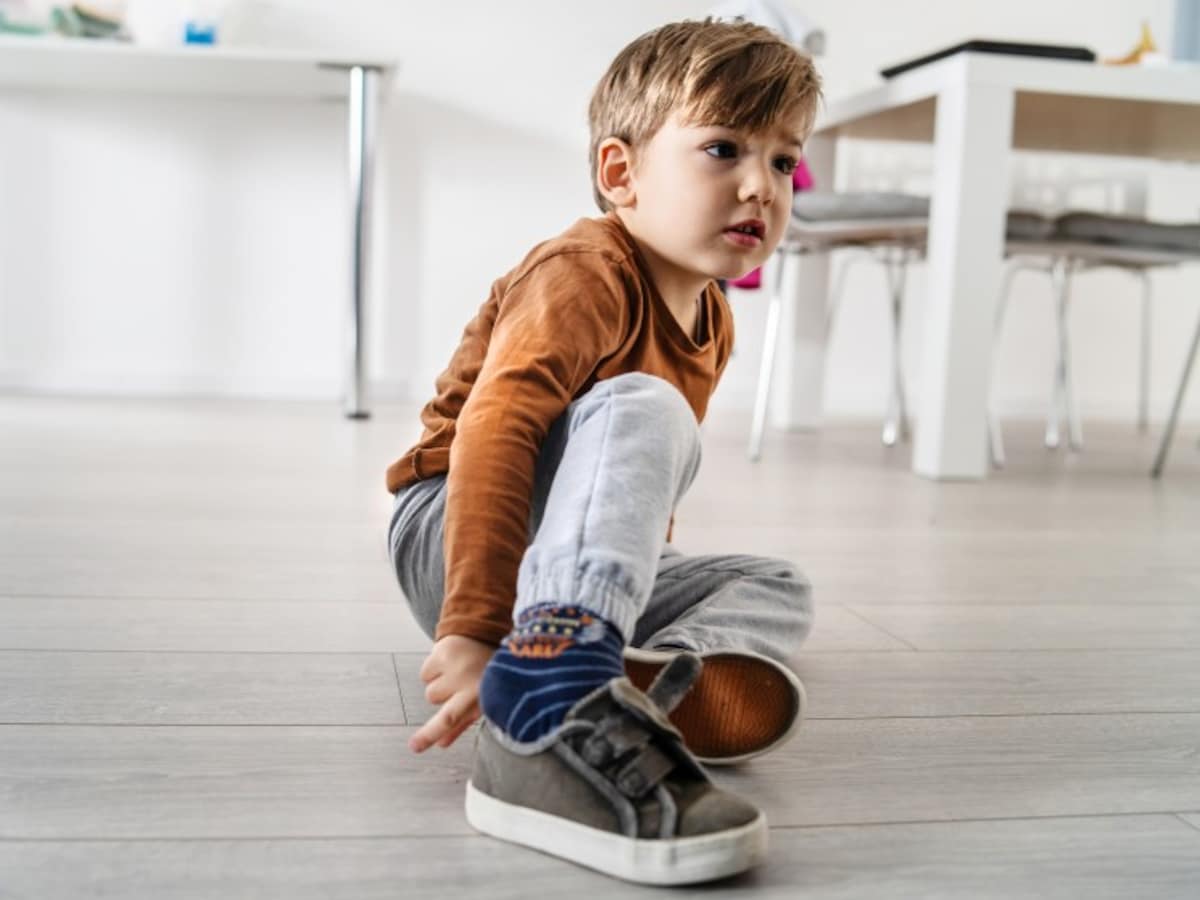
[609,109,804,289]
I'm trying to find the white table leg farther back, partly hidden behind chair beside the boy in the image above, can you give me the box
[770,134,838,428]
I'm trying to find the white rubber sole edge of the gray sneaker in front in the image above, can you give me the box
[467,781,767,884]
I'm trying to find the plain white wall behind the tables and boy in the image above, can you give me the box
[0,0,1200,420]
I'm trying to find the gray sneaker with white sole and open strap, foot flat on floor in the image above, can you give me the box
[467,653,767,884]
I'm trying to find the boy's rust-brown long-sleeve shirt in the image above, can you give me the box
[388,214,733,643]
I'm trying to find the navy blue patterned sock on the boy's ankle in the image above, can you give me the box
[479,604,625,742]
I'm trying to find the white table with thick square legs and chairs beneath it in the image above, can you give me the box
[774,53,1200,479]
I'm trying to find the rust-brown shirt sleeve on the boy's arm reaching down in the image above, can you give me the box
[437,252,629,643]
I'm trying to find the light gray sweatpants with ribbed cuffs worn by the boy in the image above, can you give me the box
[389,373,812,662]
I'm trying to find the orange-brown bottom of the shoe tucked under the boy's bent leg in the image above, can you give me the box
[625,647,805,766]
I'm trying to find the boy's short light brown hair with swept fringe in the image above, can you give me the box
[588,19,821,212]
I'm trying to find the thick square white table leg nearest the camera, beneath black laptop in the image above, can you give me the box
[912,78,1014,479]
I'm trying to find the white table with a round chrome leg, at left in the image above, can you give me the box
[0,36,395,419]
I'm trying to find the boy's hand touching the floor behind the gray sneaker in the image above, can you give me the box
[408,635,496,754]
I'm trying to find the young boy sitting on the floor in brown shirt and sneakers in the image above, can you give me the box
[388,20,820,883]
